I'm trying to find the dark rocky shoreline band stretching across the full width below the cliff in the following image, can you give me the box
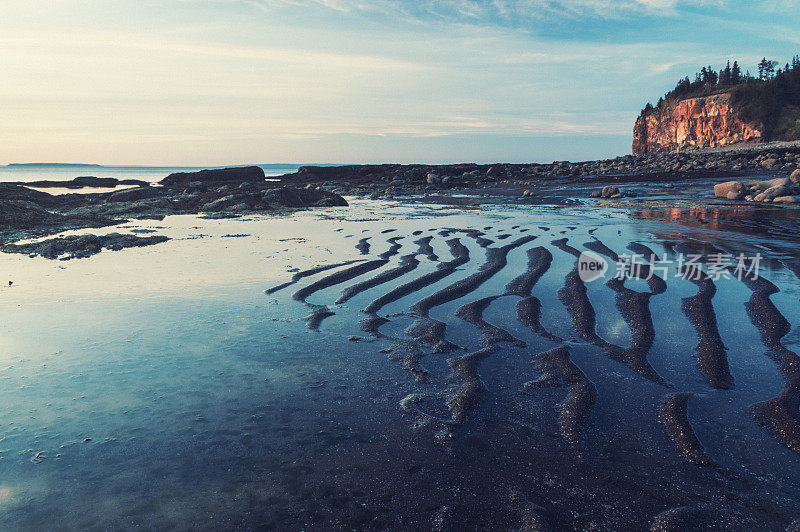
[0,145,800,257]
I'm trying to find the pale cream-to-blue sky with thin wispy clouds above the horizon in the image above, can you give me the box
[0,0,800,166]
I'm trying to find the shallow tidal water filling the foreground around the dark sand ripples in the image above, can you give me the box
[0,200,800,530]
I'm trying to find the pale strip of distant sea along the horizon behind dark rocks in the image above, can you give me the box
[0,164,300,182]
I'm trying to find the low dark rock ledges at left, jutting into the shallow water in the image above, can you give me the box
[0,167,347,258]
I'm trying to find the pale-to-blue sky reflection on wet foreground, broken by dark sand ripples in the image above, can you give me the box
[0,200,800,528]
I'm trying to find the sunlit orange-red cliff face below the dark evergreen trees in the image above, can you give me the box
[633,94,762,155]
